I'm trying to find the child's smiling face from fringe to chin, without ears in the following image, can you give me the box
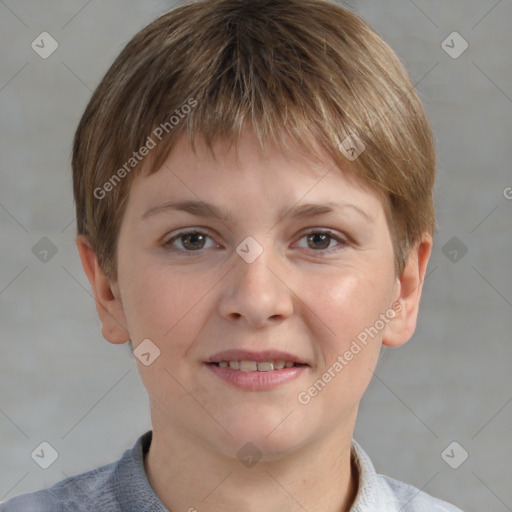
[112,131,399,458]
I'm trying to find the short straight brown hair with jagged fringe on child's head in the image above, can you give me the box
[72,0,435,281]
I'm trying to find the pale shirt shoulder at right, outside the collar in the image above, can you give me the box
[378,474,462,512]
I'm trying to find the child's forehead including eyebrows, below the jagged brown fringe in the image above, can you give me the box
[123,134,384,240]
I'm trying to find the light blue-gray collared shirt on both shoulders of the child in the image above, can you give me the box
[0,431,462,512]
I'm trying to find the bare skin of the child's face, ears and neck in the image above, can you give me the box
[77,125,432,512]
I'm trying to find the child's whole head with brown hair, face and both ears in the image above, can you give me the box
[72,0,435,456]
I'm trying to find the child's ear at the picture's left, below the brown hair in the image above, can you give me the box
[76,235,130,344]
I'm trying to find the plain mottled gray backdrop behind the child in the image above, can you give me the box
[0,0,512,512]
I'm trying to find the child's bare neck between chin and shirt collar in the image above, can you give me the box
[144,423,358,512]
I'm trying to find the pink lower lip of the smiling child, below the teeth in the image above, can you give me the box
[206,364,308,391]
